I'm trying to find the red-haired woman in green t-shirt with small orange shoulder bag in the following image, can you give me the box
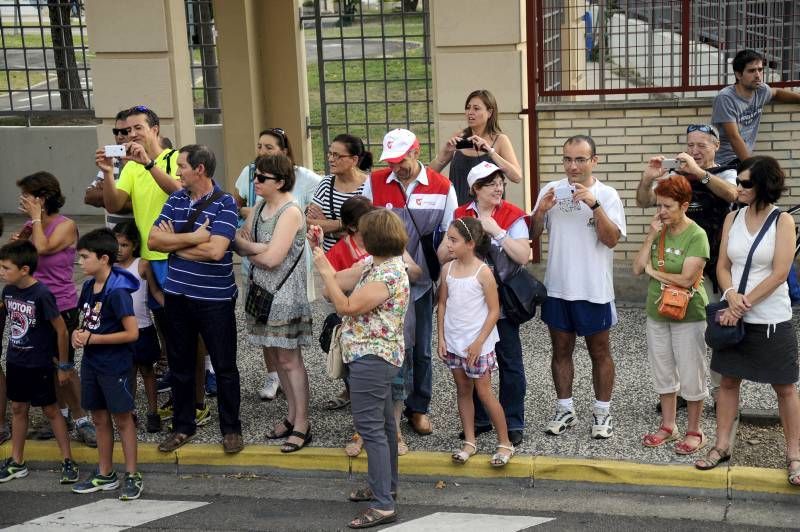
[633,174,709,454]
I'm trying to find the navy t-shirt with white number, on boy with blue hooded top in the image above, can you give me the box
[78,280,134,375]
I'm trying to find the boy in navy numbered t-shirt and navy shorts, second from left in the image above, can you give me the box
[72,229,142,500]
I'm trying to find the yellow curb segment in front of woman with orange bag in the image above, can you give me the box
[533,456,728,490]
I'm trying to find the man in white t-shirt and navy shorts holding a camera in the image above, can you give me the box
[531,135,625,438]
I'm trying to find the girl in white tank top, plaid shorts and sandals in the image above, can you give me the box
[437,218,514,467]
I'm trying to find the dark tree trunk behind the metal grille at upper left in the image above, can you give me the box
[47,0,86,109]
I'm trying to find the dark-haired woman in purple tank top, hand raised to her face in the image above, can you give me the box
[11,172,97,447]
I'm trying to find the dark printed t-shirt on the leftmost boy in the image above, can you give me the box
[3,282,60,368]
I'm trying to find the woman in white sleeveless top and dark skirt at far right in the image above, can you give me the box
[695,156,800,486]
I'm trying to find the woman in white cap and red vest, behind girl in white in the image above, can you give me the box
[454,161,531,446]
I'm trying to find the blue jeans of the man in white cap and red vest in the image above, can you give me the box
[406,288,433,415]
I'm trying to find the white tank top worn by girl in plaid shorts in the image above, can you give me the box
[444,261,500,358]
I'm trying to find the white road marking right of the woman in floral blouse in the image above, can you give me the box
[383,512,553,532]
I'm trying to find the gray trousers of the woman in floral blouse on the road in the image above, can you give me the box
[348,355,400,511]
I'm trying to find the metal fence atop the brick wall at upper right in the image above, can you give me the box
[529,0,800,101]
